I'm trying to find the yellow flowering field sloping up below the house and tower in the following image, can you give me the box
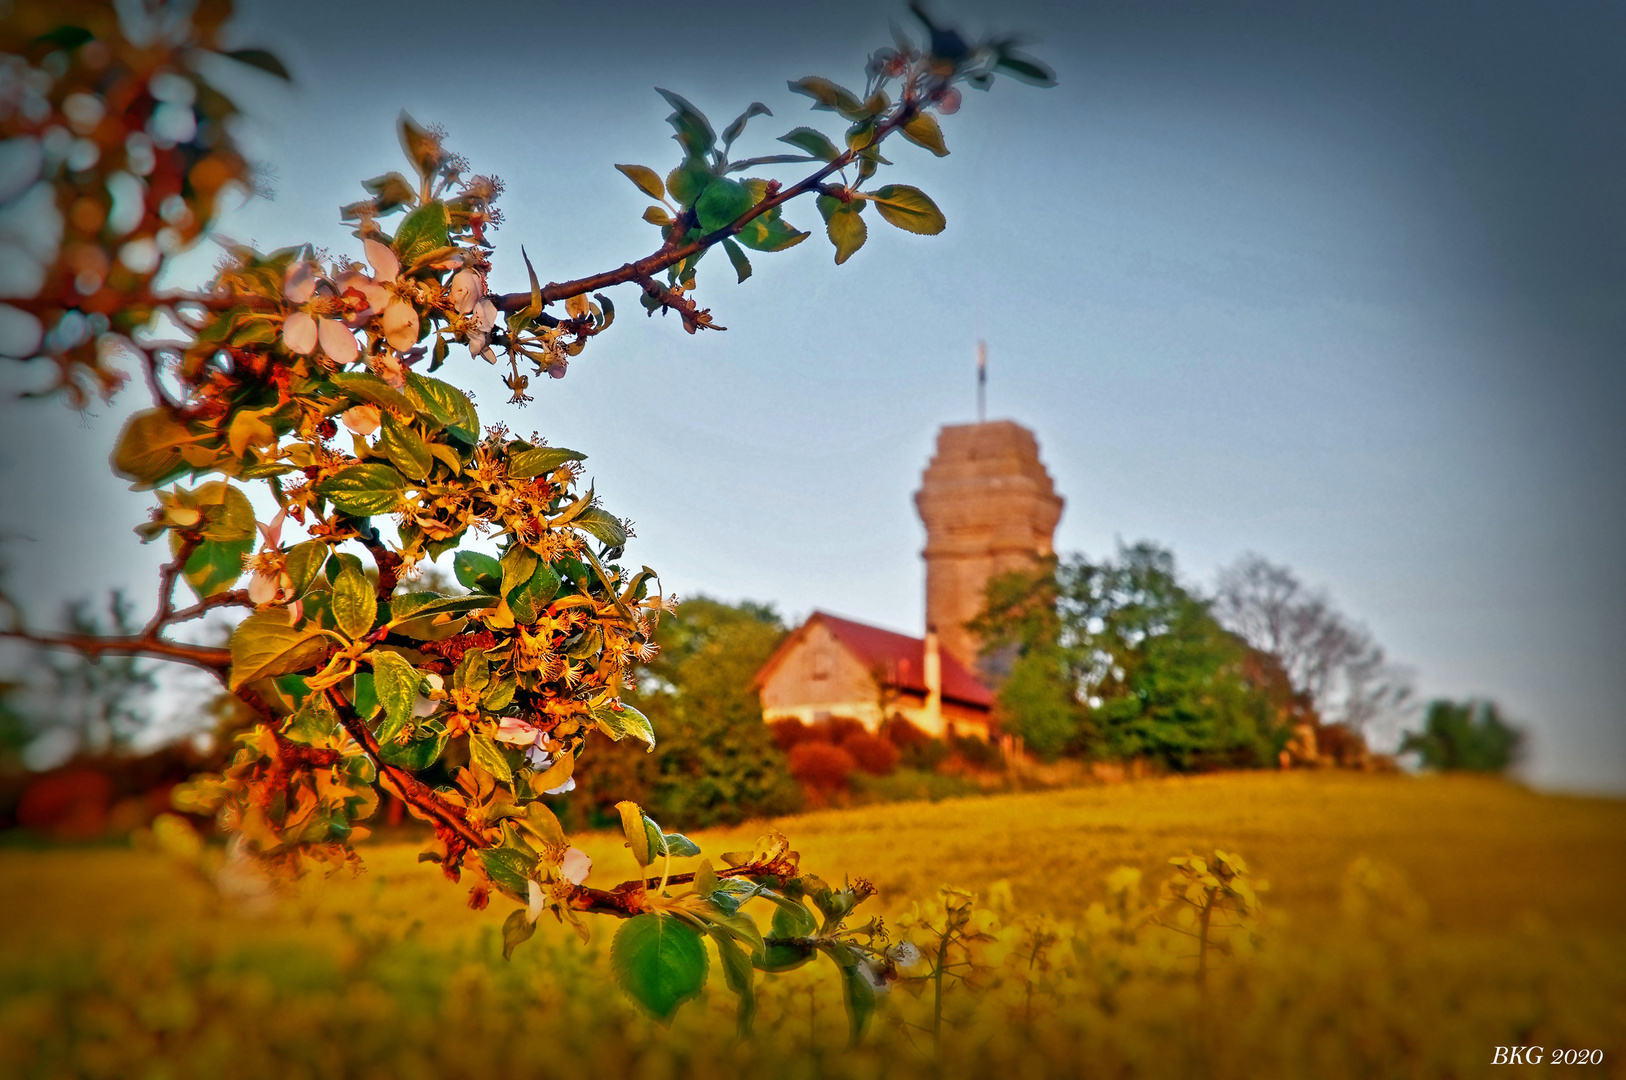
[0,773,1626,1080]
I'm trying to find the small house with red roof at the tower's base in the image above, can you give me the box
[756,612,993,738]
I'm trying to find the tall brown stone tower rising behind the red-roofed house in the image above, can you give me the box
[915,420,1062,670]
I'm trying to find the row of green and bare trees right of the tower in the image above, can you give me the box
[972,542,1519,771]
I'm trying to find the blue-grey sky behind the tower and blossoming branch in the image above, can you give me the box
[0,0,1626,792]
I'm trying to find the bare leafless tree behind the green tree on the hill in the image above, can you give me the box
[1213,553,1413,735]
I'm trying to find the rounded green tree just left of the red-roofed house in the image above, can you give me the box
[584,597,800,828]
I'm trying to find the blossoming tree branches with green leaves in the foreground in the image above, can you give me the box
[0,0,1054,1036]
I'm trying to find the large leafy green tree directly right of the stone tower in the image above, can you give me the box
[974,542,1285,769]
